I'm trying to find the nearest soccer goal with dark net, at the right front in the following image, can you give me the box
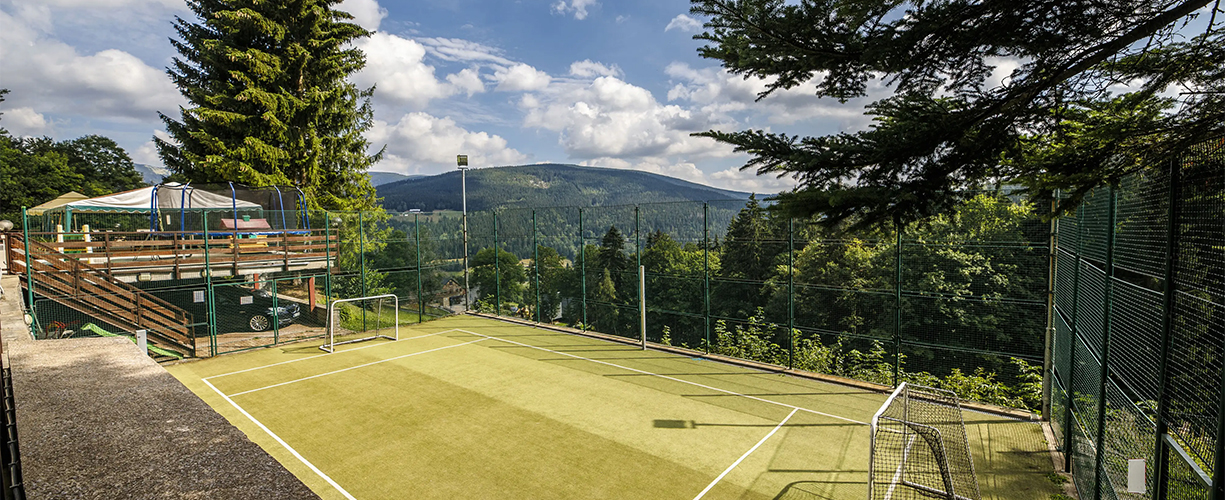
[867,384,981,500]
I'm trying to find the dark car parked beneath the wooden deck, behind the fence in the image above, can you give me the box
[168,286,301,333]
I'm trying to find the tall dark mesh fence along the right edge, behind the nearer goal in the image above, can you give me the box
[1050,141,1225,500]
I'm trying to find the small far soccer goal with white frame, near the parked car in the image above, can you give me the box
[319,294,399,353]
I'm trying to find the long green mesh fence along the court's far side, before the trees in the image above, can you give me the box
[469,192,1051,411]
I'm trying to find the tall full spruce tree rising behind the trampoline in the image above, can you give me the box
[154,0,382,210]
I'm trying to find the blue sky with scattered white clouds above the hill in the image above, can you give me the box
[0,0,880,192]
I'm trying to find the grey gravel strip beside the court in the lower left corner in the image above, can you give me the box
[0,275,319,500]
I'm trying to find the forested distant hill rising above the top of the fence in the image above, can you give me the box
[377,163,748,212]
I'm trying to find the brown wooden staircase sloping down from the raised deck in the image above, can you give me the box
[7,235,196,357]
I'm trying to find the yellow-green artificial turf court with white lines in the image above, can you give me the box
[169,316,1060,500]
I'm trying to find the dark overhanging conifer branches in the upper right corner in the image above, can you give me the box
[692,0,1225,225]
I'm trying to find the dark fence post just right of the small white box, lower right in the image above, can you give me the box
[1153,161,1180,500]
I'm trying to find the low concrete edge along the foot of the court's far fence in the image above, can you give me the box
[466,311,1038,421]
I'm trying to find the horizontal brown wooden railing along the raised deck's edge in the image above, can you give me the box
[29,229,338,275]
